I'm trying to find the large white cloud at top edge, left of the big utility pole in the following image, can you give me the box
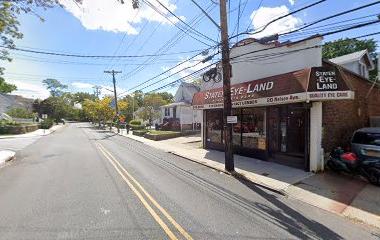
[59,0,185,35]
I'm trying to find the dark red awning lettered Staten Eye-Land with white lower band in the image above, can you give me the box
[192,66,354,109]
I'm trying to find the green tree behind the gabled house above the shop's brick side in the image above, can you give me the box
[322,38,377,80]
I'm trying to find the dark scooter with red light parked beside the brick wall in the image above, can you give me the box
[326,147,380,186]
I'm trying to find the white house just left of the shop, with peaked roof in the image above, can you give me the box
[160,82,202,131]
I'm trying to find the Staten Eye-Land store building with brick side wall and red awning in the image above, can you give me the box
[192,37,380,171]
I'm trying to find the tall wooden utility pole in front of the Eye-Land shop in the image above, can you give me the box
[219,0,235,172]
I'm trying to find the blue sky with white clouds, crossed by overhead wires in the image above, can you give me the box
[0,0,380,99]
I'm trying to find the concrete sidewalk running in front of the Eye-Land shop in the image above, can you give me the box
[116,130,380,228]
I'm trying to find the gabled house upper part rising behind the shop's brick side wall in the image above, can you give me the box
[330,50,375,78]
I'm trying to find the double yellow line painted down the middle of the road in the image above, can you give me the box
[96,143,193,240]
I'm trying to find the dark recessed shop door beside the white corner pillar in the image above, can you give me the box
[268,104,307,168]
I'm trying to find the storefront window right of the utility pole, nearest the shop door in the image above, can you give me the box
[241,108,266,150]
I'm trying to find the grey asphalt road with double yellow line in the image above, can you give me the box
[0,123,380,240]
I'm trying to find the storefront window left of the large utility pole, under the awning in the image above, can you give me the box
[206,109,223,144]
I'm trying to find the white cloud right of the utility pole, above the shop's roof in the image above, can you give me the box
[251,5,302,38]
